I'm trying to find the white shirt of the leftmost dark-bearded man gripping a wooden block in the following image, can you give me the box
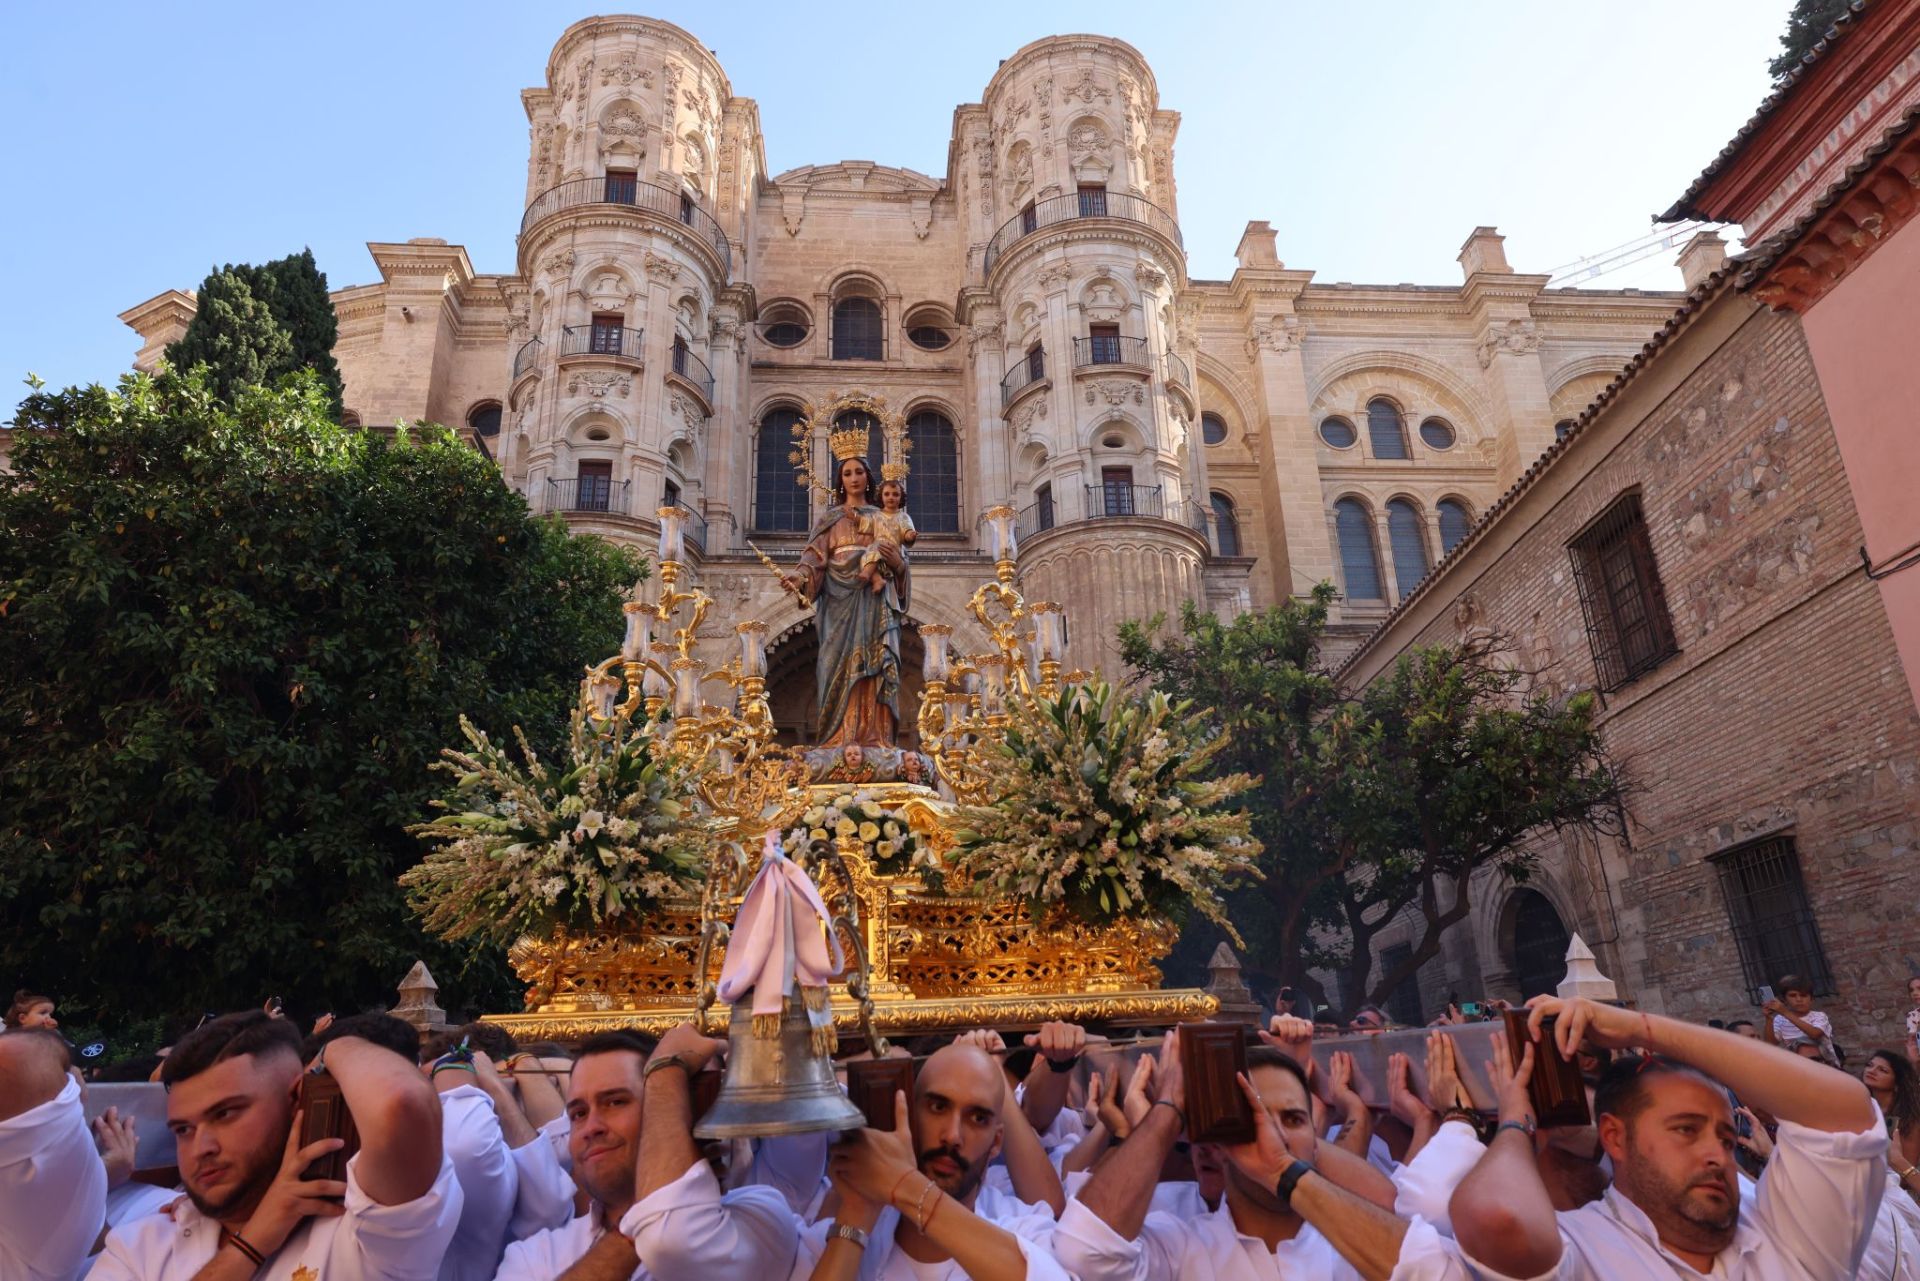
[86,1152,463,1281]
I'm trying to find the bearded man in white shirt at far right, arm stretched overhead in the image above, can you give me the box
[1452,997,1887,1281]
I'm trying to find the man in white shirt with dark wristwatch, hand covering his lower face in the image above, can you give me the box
[1054,1031,1467,1281]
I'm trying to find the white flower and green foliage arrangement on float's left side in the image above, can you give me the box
[399,693,708,945]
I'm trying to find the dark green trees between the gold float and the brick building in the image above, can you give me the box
[1121,584,1622,1021]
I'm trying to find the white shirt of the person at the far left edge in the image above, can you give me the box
[0,1076,108,1281]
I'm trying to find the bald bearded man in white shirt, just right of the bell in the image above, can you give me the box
[795,1045,1066,1281]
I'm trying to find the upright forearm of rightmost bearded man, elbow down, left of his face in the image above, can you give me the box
[1448,1031,1561,1277]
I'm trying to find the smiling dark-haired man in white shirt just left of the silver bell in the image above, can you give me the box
[497,1024,799,1281]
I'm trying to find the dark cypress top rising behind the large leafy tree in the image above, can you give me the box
[167,250,344,421]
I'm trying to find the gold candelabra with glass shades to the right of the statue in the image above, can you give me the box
[918,503,1087,805]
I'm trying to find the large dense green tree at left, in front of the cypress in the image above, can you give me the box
[0,371,643,1022]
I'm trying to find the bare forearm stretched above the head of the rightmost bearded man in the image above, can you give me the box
[1642,1014,1874,1133]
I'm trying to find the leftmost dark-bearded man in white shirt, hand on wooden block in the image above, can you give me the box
[88,1010,461,1281]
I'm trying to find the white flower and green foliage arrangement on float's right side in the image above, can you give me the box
[956,680,1260,941]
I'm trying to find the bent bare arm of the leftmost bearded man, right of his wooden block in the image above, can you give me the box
[323,1037,445,1206]
